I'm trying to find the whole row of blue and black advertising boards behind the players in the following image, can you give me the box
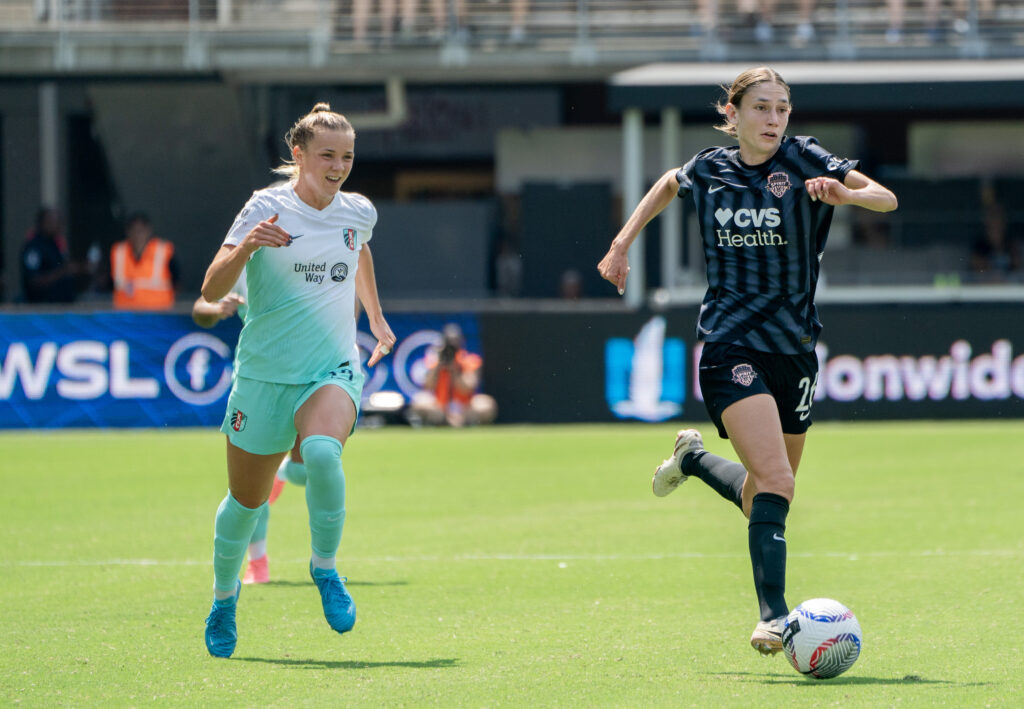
[0,302,1024,428]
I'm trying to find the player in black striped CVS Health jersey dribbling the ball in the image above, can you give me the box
[598,67,896,655]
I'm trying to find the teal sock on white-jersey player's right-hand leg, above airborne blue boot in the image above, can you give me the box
[300,435,345,558]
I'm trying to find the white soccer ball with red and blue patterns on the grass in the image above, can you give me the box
[782,598,861,679]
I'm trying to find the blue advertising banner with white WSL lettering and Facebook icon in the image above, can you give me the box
[0,312,480,428]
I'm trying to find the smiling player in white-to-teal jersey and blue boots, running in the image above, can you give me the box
[203,103,395,657]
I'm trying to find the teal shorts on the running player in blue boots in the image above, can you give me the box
[220,363,365,455]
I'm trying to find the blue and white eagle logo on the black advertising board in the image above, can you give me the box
[604,316,686,421]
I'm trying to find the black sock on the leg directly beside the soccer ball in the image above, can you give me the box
[748,493,790,620]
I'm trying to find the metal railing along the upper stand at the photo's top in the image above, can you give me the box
[0,0,1024,55]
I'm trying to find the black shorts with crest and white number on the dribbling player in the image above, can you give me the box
[699,342,818,439]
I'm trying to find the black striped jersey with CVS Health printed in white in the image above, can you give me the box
[676,135,857,355]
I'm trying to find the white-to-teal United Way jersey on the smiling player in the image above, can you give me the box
[224,182,377,384]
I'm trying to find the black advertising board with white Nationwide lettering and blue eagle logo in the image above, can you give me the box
[480,303,1024,422]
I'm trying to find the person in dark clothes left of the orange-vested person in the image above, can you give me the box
[22,207,86,303]
